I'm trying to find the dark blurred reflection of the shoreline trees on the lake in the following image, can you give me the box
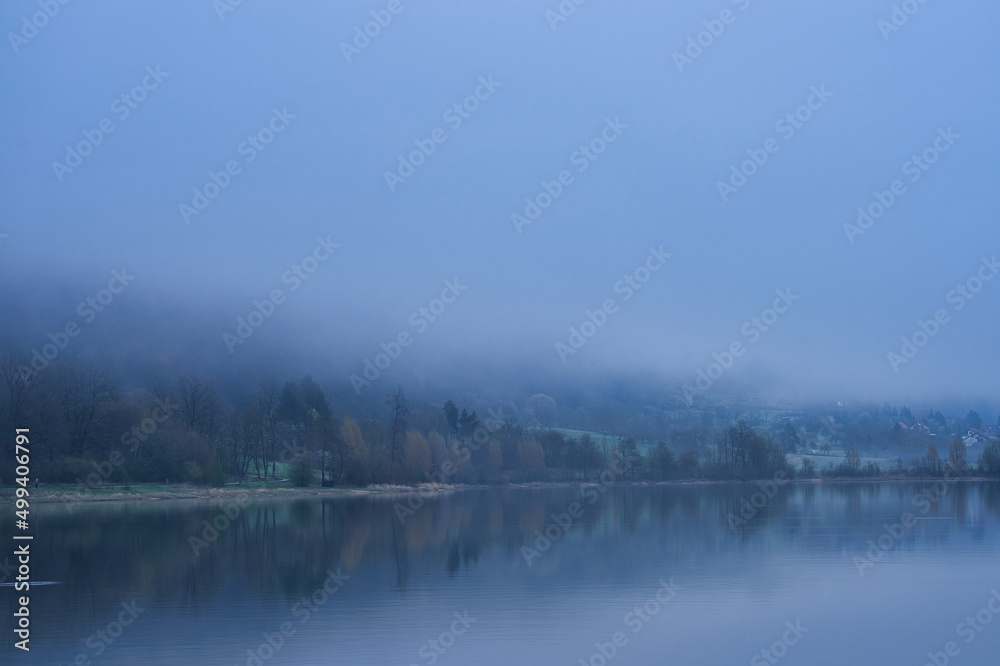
[17,482,1000,630]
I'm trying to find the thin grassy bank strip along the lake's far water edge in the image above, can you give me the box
[0,476,1000,504]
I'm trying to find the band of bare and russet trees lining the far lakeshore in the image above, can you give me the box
[0,356,1000,488]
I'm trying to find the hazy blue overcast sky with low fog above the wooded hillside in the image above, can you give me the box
[0,0,1000,399]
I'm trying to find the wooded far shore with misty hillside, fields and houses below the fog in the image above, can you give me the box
[0,355,1000,489]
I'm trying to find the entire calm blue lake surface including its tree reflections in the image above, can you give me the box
[0,482,1000,666]
